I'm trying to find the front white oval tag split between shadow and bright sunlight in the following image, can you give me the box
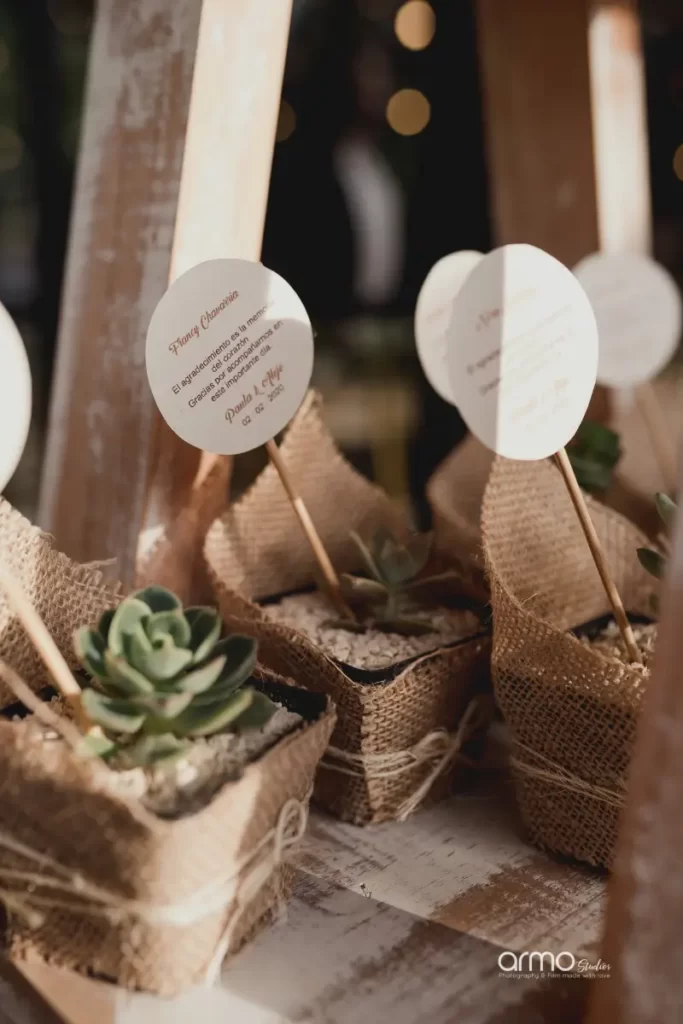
[447,245,598,460]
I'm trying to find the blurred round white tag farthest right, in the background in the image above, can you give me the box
[574,253,681,387]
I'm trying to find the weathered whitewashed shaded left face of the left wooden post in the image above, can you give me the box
[40,0,201,581]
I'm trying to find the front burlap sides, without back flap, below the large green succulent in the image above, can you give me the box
[0,673,335,996]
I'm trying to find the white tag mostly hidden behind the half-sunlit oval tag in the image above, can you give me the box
[415,249,483,404]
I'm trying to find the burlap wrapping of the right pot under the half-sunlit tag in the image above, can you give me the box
[482,459,652,866]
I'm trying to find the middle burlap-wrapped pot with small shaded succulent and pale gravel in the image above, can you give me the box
[205,393,489,824]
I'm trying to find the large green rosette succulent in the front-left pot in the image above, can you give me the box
[75,587,274,765]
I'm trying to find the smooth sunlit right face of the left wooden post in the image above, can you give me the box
[138,0,292,558]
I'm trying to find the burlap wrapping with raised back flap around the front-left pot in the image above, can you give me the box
[0,503,334,996]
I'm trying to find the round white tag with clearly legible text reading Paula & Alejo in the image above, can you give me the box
[146,259,313,455]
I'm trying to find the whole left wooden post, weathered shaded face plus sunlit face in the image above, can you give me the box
[40,0,290,583]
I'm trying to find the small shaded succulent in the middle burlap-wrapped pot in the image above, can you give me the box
[327,529,459,636]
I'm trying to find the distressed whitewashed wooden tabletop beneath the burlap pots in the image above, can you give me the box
[0,741,605,1024]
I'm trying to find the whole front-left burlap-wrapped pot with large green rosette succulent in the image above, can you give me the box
[0,503,334,995]
